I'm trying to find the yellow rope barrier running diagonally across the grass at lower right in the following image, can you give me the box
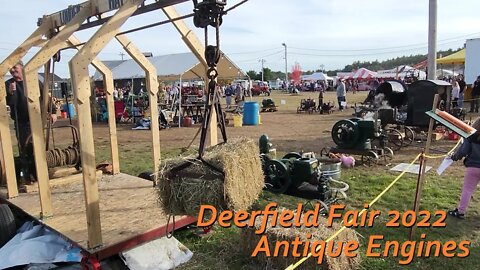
[285,140,462,270]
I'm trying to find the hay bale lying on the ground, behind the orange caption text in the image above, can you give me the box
[240,209,361,270]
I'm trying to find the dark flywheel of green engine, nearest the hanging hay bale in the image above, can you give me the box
[264,159,292,193]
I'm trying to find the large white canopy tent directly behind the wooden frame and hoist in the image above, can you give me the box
[93,53,246,81]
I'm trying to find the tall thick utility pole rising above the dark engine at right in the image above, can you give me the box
[427,0,437,80]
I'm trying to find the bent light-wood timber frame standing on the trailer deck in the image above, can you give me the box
[0,0,217,249]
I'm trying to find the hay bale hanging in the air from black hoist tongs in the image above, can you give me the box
[157,138,264,216]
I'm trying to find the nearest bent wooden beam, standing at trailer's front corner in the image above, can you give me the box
[69,0,143,248]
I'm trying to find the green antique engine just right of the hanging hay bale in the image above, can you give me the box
[259,135,348,211]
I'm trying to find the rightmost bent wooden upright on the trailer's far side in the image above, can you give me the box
[116,35,161,176]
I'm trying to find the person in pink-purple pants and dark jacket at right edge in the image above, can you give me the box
[448,118,480,219]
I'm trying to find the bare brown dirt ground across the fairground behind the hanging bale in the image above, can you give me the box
[43,92,367,152]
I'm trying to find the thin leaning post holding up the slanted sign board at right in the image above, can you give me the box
[410,94,440,239]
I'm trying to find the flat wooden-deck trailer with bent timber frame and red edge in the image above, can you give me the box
[0,0,233,269]
